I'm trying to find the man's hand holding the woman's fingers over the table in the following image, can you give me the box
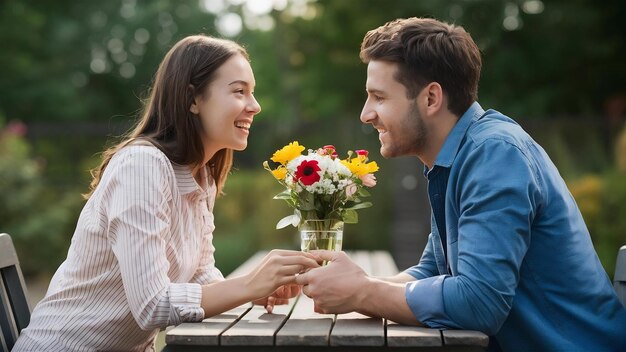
[296,250,369,314]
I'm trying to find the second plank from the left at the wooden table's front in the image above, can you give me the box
[220,298,296,346]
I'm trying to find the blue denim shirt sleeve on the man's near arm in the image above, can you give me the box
[405,139,542,335]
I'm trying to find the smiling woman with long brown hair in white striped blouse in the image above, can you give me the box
[14,35,318,351]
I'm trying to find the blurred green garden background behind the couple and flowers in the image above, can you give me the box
[0,0,626,302]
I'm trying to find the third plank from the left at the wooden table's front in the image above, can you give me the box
[276,295,335,346]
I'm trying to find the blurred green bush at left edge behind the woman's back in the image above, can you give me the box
[0,121,82,275]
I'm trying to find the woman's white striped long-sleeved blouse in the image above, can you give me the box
[14,145,223,351]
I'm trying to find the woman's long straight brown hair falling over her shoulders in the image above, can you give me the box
[83,35,249,199]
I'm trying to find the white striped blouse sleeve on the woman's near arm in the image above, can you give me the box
[102,146,204,330]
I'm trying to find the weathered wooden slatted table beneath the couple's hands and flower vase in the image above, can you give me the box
[163,251,489,352]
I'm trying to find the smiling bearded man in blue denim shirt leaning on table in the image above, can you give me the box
[297,18,626,351]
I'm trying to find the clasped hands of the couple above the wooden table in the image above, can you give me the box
[253,250,368,314]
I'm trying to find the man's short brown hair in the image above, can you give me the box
[360,17,482,116]
